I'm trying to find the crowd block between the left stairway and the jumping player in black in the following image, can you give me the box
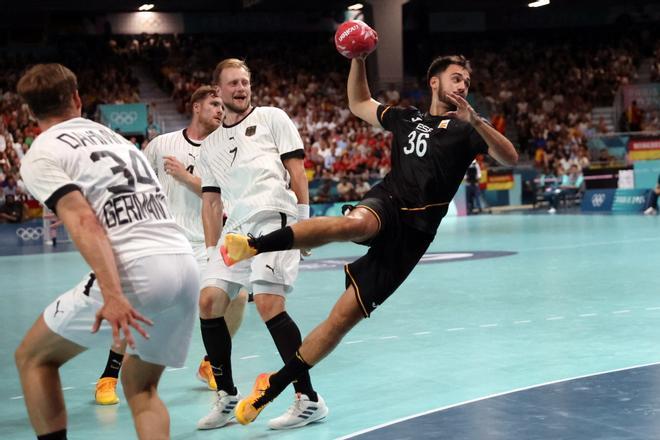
[116,35,400,202]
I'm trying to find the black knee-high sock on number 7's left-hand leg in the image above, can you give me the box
[199,316,236,395]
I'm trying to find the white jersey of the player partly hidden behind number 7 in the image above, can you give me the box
[144,129,204,243]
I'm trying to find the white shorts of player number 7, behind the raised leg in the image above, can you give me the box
[202,211,300,299]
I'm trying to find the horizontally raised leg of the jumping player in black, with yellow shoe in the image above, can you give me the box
[220,205,381,265]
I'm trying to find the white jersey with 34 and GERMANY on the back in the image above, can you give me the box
[21,118,192,262]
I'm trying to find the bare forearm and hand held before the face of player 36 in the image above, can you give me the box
[447,93,518,166]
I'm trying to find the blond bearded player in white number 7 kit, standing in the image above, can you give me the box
[197,58,328,429]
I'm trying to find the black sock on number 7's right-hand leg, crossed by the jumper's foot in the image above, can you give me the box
[266,312,318,402]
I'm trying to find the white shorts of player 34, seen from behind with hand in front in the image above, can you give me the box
[43,254,199,368]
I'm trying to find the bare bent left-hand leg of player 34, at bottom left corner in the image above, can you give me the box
[15,315,85,438]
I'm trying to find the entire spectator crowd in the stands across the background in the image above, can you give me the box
[0,24,660,220]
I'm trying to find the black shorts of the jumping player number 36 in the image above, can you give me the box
[344,186,433,318]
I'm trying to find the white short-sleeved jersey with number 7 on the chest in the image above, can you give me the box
[199,107,305,231]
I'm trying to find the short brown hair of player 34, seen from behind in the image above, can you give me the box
[16,63,78,119]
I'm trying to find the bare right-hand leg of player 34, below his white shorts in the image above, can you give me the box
[121,355,170,439]
